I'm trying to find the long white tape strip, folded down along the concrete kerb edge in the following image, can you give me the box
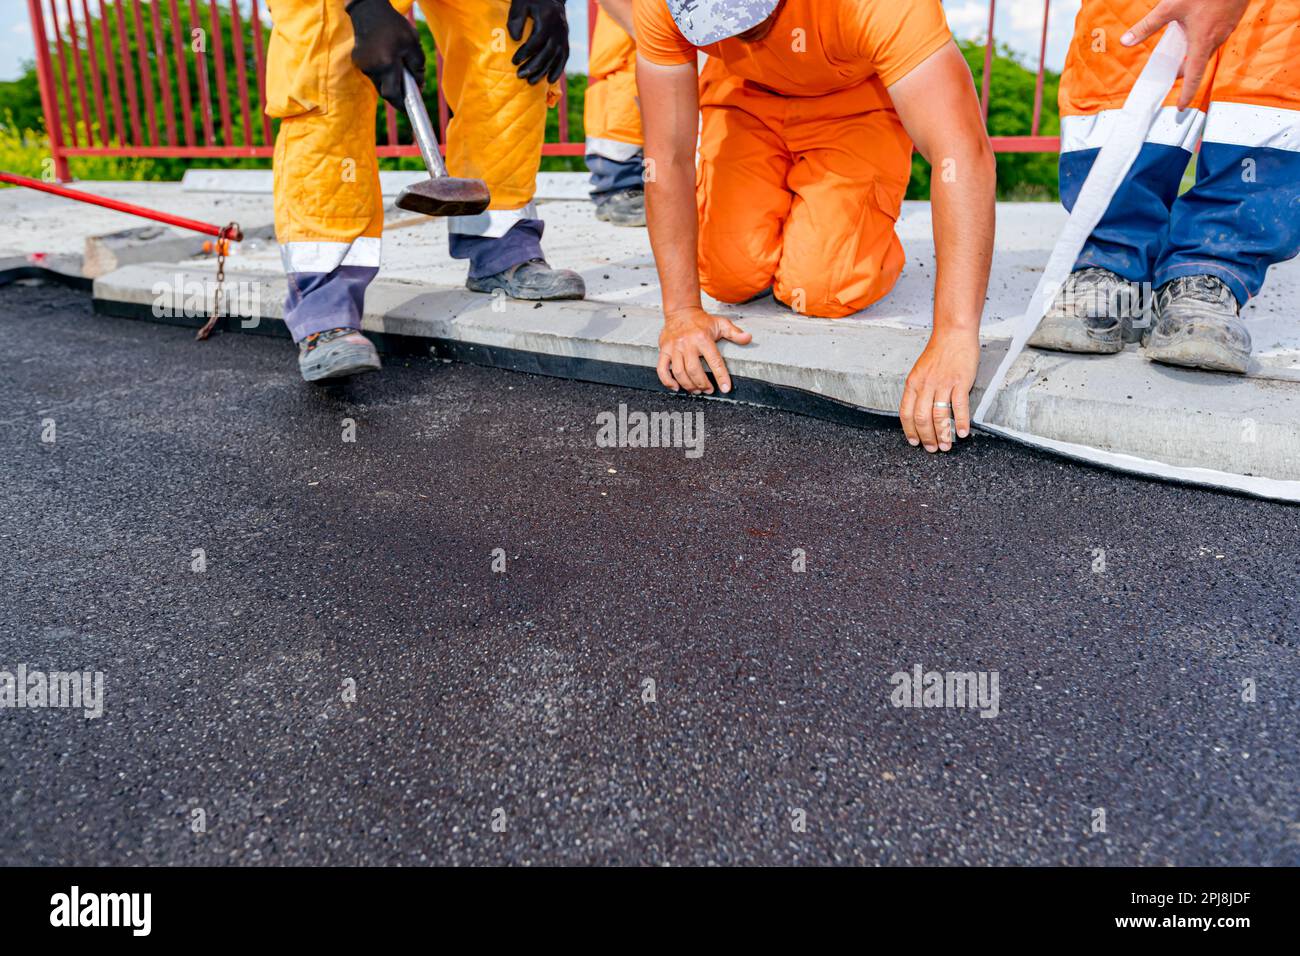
[974,23,1300,502]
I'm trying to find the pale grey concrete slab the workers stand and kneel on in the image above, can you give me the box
[0,174,1300,494]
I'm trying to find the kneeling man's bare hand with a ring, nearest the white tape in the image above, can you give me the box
[898,328,979,451]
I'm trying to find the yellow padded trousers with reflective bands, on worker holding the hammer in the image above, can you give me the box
[267,0,559,338]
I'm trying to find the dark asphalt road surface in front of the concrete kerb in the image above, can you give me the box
[0,285,1300,865]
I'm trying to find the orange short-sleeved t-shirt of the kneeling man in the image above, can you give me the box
[636,0,952,96]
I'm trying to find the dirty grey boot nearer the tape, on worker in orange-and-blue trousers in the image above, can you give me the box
[1028,267,1143,355]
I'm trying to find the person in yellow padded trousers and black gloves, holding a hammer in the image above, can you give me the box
[267,0,585,381]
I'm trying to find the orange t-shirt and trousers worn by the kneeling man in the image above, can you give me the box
[636,0,952,319]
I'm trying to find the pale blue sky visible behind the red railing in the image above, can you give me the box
[0,0,1079,79]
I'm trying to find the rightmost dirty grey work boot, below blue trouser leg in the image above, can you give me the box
[1143,276,1251,375]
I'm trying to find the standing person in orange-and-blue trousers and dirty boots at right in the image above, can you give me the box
[1030,0,1300,373]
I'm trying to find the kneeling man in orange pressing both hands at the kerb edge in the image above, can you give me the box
[636,0,996,451]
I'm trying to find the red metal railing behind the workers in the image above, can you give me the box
[27,0,1060,179]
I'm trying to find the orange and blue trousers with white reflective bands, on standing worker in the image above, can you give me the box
[1060,0,1300,304]
